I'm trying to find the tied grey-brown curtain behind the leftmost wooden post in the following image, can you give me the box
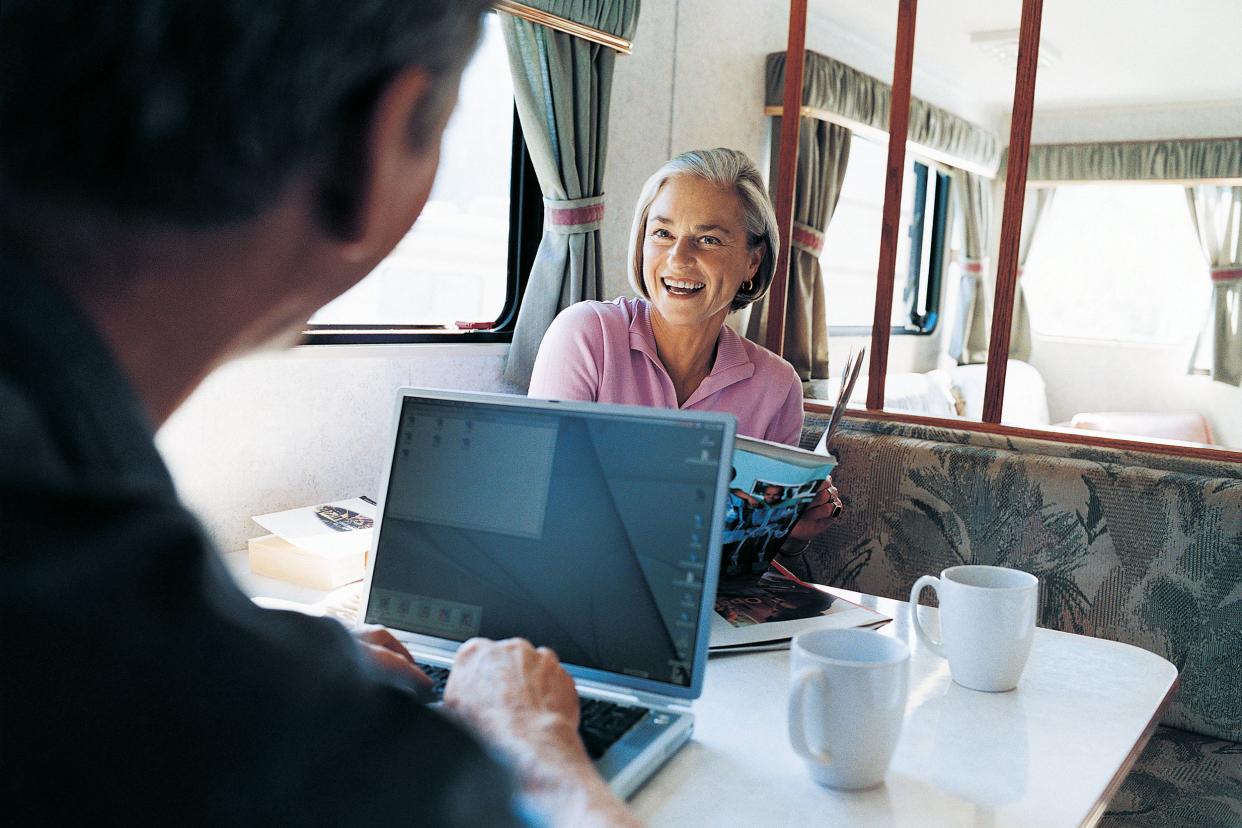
[746,117,850,382]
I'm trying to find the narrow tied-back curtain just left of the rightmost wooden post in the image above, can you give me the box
[949,170,992,365]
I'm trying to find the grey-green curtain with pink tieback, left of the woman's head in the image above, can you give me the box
[501,0,638,389]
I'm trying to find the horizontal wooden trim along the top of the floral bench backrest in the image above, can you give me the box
[804,400,1242,466]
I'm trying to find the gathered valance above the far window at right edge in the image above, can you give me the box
[1026,138,1242,184]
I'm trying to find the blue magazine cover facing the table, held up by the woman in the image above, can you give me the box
[720,437,836,586]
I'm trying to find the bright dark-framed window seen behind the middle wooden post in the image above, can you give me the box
[820,134,950,335]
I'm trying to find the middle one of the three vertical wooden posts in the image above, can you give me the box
[867,0,918,410]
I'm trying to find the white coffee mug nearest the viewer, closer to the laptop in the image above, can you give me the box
[789,629,910,790]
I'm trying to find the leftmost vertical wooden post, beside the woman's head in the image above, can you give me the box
[765,0,806,355]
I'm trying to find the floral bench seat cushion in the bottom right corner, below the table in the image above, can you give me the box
[1099,727,1242,828]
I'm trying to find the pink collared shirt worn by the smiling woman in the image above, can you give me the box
[529,297,802,446]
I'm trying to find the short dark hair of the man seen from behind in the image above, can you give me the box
[0,0,489,225]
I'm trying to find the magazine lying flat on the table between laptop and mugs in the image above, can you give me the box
[709,561,892,652]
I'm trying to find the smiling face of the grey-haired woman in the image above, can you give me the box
[642,175,764,331]
